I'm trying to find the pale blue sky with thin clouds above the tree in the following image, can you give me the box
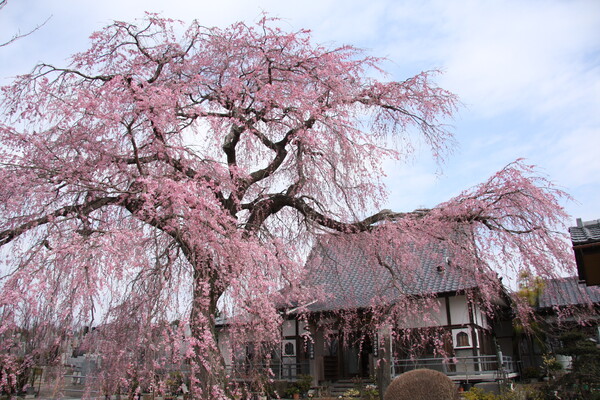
[0,0,600,224]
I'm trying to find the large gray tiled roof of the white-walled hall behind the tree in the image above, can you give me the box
[304,236,476,311]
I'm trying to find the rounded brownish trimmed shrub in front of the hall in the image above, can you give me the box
[383,369,459,400]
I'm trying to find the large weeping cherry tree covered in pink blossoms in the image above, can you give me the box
[0,14,572,399]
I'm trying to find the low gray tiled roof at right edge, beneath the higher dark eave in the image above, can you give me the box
[539,276,600,308]
